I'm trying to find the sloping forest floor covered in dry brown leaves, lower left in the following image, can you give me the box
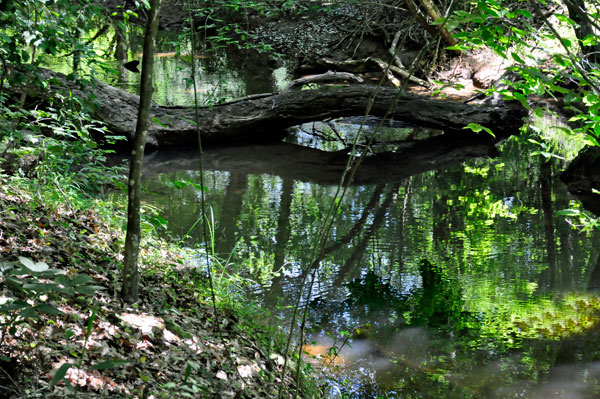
[0,176,310,398]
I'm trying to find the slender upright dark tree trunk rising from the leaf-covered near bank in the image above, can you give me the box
[121,0,160,303]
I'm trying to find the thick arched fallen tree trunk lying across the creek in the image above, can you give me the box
[36,70,525,147]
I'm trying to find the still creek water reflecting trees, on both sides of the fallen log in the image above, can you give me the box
[99,45,600,399]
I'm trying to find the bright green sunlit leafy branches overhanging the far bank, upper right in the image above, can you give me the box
[448,0,600,145]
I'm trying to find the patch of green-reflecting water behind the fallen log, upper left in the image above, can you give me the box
[39,30,290,106]
